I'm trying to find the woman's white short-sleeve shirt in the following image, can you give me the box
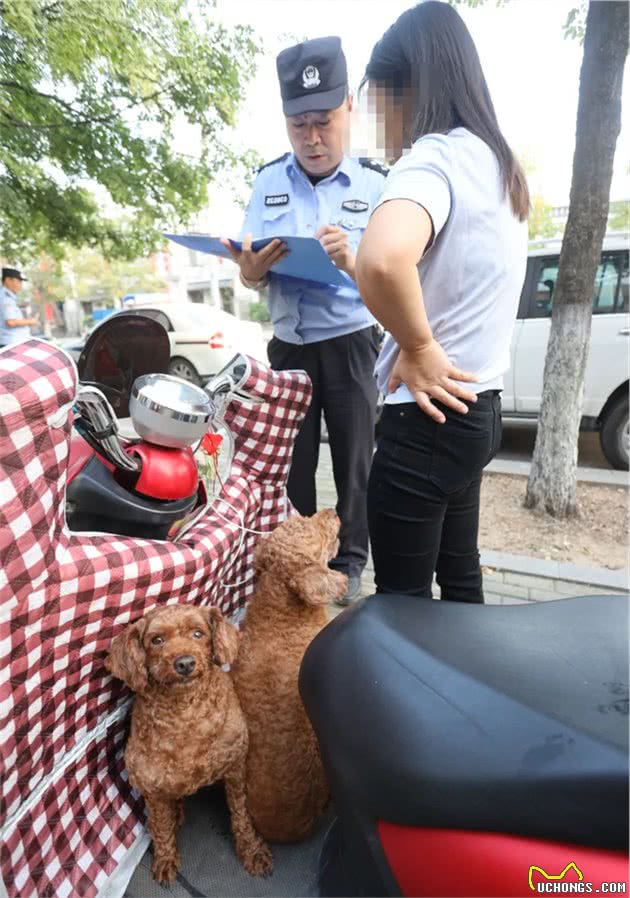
[376,128,527,402]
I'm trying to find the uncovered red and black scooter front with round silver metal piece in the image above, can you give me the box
[66,313,247,539]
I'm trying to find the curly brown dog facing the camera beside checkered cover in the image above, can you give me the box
[105,605,272,882]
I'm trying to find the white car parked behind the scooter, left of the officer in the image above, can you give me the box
[65,298,267,384]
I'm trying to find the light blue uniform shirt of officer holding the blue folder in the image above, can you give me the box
[241,153,385,344]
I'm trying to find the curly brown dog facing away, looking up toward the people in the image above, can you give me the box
[232,509,348,842]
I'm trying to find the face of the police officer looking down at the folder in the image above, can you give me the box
[286,97,352,177]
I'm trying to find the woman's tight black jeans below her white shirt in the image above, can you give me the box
[368,390,501,602]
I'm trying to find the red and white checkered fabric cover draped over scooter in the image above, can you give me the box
[0,340,310,898]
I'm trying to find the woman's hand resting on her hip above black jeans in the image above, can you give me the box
[389,340,477,424]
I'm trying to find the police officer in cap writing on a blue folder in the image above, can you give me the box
[225,37,387,604]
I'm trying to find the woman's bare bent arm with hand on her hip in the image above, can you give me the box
[355,200,476,423]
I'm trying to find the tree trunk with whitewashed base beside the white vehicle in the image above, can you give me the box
[525,0,628,518]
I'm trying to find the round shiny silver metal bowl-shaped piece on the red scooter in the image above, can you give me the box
[129,374,215,449]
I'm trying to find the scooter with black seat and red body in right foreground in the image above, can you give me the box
[300,595,628,898]
